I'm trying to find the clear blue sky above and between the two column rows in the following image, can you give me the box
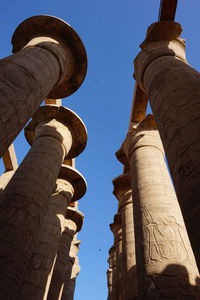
[0,0,200,300]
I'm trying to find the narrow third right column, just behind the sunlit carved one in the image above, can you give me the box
[113,173,137,300]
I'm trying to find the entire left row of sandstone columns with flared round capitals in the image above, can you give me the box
[0,16,87,300]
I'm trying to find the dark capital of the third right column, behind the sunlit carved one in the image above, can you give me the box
[112,173,131,200]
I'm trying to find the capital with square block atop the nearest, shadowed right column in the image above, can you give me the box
[134,21,187,91]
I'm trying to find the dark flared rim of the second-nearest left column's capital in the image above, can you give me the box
[25,105,87,159]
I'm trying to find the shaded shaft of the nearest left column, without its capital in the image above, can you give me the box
[0,42,65,156]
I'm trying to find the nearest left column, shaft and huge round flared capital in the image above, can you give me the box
[0,16,87,157]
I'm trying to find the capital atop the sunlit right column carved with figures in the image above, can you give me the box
[122,114,164,159]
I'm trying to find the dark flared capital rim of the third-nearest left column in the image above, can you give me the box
[58,165,87,202]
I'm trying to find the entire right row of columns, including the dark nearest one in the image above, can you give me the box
[107,17,200,300]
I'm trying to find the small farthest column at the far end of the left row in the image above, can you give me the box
[61,239,81,300]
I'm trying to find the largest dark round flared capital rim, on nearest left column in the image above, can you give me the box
[11,15,87,99]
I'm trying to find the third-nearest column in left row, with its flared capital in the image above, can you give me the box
[18,165,86,300]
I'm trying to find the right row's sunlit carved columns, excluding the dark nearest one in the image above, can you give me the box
[108,115,200,300]
